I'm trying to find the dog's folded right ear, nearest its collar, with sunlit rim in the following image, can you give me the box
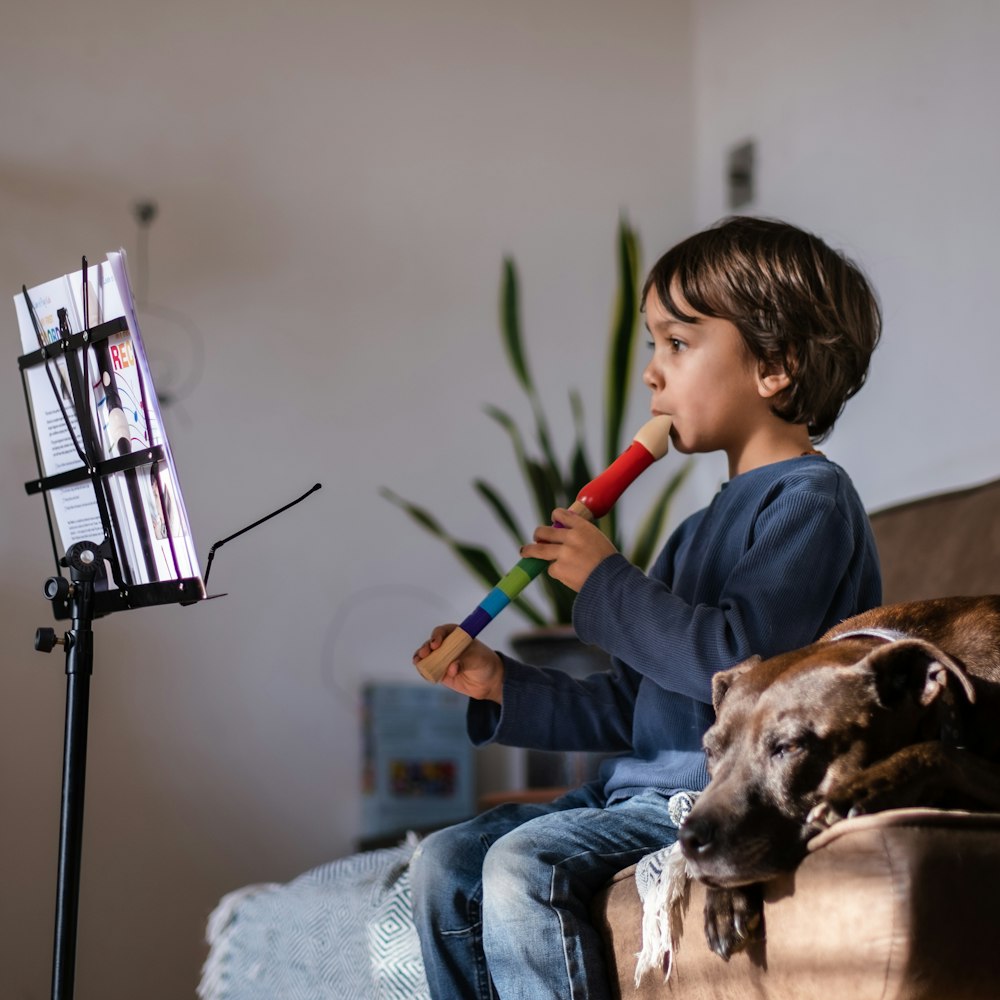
[862,639,976,708]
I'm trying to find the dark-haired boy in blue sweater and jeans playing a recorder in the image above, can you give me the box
[411,217,881,1000]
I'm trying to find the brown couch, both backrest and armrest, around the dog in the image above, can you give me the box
[596,480,1000,1000]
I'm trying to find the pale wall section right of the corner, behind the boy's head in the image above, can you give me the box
[692,0,1000,507]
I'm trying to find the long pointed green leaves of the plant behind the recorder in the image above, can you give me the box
[379,219,690,662]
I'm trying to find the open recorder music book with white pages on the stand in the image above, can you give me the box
[14,250,204,596]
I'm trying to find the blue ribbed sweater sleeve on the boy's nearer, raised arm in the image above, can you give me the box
[573,492,855,703]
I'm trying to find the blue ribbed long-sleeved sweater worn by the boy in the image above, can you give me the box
[468,455,882,801]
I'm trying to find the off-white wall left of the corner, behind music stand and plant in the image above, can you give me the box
[0,0,694,1000]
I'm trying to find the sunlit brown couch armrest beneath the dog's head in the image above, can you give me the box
[597,809,1000,1000]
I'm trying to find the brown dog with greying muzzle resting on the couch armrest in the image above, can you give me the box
[679,595,1000,959]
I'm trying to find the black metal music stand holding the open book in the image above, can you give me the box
[18,261,205,1000]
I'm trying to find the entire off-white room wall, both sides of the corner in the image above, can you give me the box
[7,0,1000,1000]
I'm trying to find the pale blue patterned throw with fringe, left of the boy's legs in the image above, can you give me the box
[198,834,430,1000]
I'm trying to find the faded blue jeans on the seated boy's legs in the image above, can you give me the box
[410,782,677,1000]
